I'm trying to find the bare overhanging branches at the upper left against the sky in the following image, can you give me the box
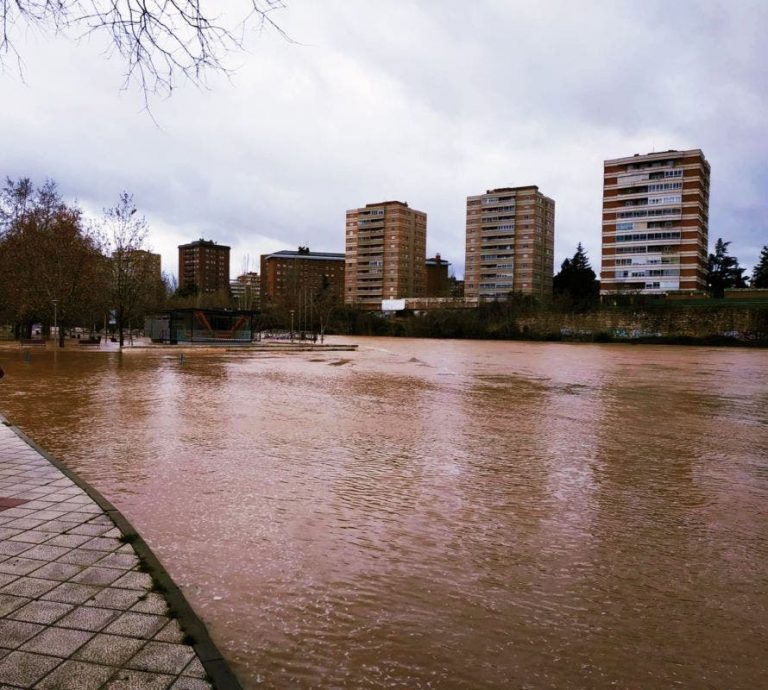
[0,0,287,96]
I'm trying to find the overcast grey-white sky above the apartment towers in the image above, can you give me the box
[0,0,768,277]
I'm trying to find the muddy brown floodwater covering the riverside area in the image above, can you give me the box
[0,339,768,690]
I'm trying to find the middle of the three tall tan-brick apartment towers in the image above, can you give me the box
[464,185,555,301]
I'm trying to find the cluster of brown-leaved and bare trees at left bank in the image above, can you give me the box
[0,178,166,346]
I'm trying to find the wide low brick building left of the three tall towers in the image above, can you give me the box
[261,247,344,306]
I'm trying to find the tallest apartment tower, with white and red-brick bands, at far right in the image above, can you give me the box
[600,149,709,295]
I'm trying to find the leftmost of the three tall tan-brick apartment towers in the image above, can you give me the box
[344,201,427,309]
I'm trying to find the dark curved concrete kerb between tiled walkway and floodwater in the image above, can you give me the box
[0,415,243,690]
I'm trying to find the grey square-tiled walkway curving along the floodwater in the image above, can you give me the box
[0,417,238,690]
